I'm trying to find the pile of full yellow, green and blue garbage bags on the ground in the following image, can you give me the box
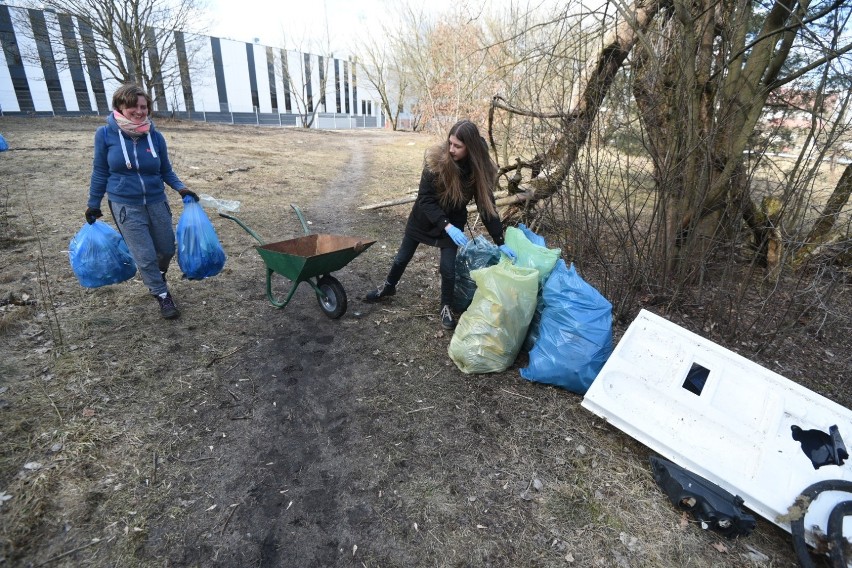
[448,225,613,395]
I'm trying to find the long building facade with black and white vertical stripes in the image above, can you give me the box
[0,4,384,129]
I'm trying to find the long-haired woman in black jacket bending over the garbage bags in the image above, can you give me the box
[365,120,515,329]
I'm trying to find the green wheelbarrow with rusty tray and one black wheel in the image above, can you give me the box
[219,204,376,319]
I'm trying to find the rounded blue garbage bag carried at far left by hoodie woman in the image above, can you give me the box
[68,221,136,288]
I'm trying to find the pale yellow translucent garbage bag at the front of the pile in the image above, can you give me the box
[448,257,539,373]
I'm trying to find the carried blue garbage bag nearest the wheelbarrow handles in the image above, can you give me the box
[177,196,225,280]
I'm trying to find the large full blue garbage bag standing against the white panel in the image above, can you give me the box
[521,259,612,395]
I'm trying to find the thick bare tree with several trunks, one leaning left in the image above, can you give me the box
[494,0,852,272]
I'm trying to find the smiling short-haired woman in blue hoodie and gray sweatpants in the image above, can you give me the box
[86,84,198,319]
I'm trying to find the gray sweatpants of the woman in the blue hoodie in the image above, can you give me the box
[109,201,175,296]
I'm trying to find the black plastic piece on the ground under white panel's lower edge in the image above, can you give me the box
[651,456,755,538]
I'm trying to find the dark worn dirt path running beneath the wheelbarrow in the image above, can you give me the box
[141,134,426,567]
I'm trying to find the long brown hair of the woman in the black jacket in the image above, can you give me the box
[426,120,497,217]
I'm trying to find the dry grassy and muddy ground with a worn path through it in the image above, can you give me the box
[0,117,852,568]
